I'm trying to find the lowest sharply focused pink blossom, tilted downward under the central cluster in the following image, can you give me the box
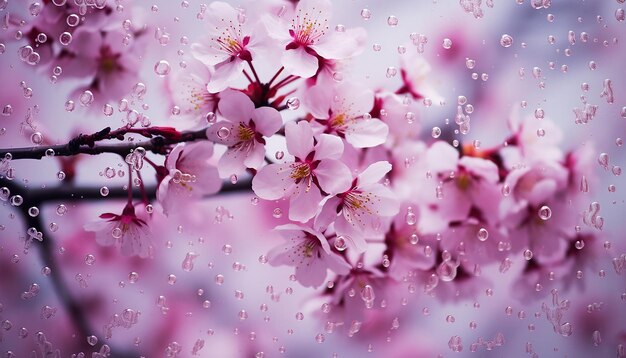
[267,224,351,287]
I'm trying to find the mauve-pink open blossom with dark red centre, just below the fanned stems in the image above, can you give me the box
[207,91,283,178]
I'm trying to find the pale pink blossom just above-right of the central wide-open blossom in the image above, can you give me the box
[305,84,389,148]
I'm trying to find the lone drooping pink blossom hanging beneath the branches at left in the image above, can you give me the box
[84,203,152,258]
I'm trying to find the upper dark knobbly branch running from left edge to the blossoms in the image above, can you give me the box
[0,127,207,160]
